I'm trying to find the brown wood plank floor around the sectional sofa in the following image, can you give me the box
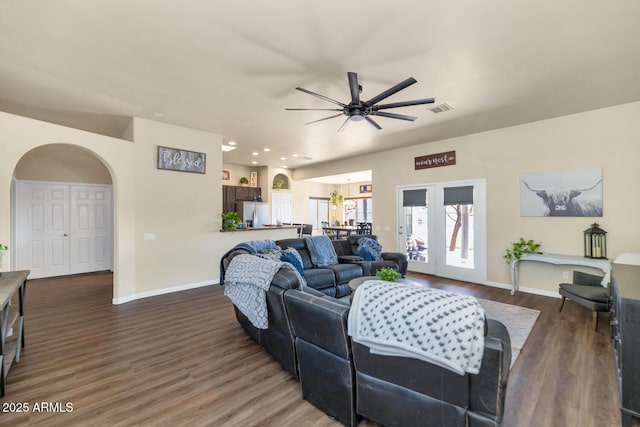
[0,274,620,427]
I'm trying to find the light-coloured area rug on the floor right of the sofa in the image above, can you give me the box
[478,298,540,367]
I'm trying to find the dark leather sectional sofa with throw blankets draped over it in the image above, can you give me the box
[221,239,511,426]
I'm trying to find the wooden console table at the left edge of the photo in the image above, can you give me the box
[0,270,29,397]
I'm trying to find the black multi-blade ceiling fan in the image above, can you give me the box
[286,72,435,132]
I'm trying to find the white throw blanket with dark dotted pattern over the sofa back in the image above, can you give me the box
[348,280,484,375]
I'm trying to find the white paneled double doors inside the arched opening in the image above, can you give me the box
[14,181,113,279]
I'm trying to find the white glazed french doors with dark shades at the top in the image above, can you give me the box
[397,180,486,282]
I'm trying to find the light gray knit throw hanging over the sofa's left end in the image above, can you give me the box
[224,254,304,329]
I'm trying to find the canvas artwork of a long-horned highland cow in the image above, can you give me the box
[520,168,602,217]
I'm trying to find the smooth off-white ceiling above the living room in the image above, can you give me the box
[0,0,640,172]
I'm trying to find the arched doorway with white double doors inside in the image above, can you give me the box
[11,144,114,290]
